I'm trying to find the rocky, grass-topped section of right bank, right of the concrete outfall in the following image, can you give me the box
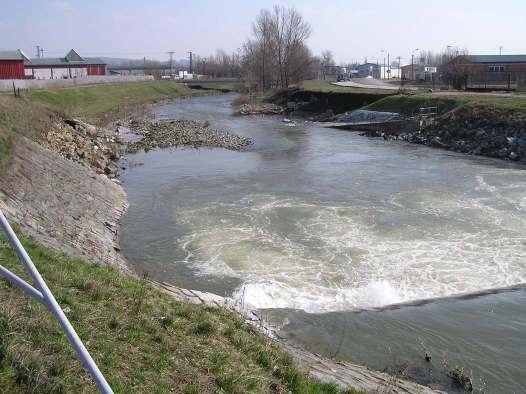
[364,95,526,162]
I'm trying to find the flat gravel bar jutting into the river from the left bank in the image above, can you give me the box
[127,120,252,153]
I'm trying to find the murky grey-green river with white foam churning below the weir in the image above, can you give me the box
[121,94,526,392]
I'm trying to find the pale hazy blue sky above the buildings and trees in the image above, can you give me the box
[0,0,526,63]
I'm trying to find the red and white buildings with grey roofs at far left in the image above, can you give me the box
[0,49,106,79]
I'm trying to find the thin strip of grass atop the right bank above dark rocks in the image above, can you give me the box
[365,94,526,115]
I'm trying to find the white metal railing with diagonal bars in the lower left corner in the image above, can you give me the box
[0,210,113,394]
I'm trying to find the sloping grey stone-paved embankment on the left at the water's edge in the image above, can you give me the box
[0,138,128,271]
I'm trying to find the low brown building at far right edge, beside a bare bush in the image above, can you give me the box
[443,55,526,90]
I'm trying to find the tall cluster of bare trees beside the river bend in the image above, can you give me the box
[242,6,313,89]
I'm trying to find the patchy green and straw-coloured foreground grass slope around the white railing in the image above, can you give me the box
[0,231,364,394]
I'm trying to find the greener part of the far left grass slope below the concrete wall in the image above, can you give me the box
[26,81,199,122]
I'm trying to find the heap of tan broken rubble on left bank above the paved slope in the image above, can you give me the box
[42,118,124,178]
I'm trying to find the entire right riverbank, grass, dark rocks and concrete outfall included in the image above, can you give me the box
[244,81,526,162]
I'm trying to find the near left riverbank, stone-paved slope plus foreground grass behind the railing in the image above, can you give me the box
[0,83,442,393]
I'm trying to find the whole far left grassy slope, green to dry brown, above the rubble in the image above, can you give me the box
[0,81,203,170]
